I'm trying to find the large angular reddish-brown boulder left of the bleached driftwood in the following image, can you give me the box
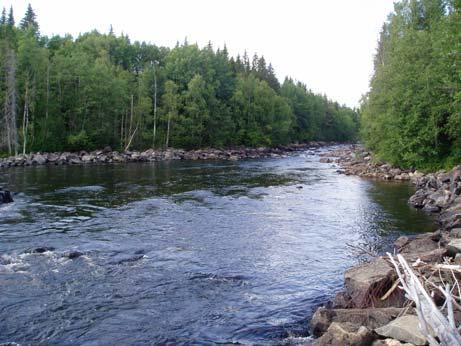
[344,257,405,308]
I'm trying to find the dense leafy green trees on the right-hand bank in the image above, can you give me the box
[361,0,461,169]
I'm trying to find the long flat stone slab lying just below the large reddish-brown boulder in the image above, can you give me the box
[310,307,406,336]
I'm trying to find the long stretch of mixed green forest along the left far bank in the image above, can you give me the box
[0,5,358,154]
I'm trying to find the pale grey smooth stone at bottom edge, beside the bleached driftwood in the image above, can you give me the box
[375,315,427,346]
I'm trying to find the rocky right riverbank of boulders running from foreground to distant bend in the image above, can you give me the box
[310,146,461,346]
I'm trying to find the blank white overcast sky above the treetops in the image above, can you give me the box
[0,0,393,107]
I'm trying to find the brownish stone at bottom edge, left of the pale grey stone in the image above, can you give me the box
[312,322,375,346]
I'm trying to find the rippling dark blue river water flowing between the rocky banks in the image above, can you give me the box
[0,147,433,345]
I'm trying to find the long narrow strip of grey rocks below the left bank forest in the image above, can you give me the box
[0,142,331,168]
